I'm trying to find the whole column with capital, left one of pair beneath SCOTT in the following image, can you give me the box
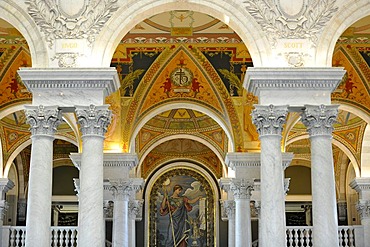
[252,105,288,247]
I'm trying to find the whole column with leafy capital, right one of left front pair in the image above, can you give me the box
[76,105,112,247]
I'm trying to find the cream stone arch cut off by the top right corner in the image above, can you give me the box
[315,0,370,67]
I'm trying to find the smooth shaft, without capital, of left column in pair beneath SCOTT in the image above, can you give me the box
[259,135,286,247]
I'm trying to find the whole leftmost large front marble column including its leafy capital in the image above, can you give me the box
[25,105,62,247]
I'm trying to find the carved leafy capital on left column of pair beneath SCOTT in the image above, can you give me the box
[252,105,288,137]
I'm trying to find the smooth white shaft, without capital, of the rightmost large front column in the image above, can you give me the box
[310,135,339,247]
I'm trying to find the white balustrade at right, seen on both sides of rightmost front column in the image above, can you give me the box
[286,226,364,247]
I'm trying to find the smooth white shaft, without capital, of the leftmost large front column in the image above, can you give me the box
[26,135,54,247]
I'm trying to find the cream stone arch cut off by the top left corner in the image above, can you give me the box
[0,0,49,68]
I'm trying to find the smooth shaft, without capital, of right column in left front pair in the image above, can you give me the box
[78,135,105,247]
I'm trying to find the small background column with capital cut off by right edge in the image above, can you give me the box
[350,177,370,247]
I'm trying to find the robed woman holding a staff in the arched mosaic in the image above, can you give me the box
[160,184,201,247]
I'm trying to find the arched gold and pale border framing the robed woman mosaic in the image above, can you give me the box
[144,162,220,246]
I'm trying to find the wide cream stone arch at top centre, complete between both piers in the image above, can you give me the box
[91,0,271,67]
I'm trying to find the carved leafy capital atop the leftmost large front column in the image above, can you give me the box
[25,105,62,136]
